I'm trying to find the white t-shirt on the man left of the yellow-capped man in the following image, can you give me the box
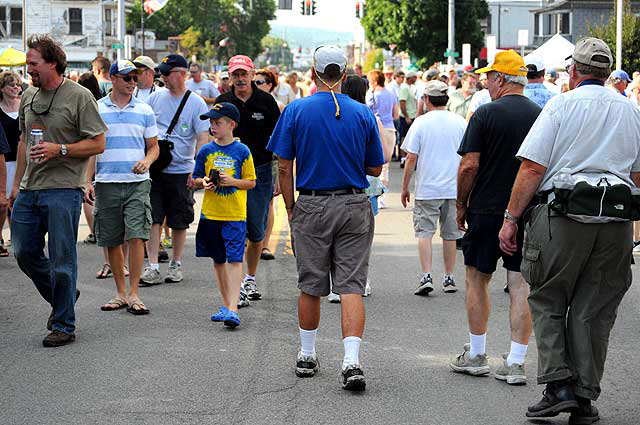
[402,110,467,200]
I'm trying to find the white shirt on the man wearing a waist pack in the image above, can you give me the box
[516,85,640,191]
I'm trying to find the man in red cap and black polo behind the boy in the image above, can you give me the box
[216,55,280,307]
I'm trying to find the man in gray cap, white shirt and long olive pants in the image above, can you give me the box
[500,37,640,424]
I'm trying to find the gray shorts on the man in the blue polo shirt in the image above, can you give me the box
[291,194,374,297]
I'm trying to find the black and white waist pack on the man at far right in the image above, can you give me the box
[549,177,640,223]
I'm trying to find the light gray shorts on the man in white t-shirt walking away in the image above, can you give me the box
[413,199,463,241]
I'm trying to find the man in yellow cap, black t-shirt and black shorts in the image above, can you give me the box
[450,50,541,384]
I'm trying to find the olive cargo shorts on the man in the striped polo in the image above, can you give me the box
[93,180,151,247]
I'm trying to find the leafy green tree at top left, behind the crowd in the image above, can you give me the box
[127,0,276,61]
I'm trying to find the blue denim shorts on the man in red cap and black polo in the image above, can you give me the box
[247,162,273,242]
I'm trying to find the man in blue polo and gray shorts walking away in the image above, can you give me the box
[267,46,384,391]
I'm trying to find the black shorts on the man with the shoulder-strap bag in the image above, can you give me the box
[151,173,195,230]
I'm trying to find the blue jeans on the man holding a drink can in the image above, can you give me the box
[11,189,83,334]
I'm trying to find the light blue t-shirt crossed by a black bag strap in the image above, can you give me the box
[148,90,209,174]
